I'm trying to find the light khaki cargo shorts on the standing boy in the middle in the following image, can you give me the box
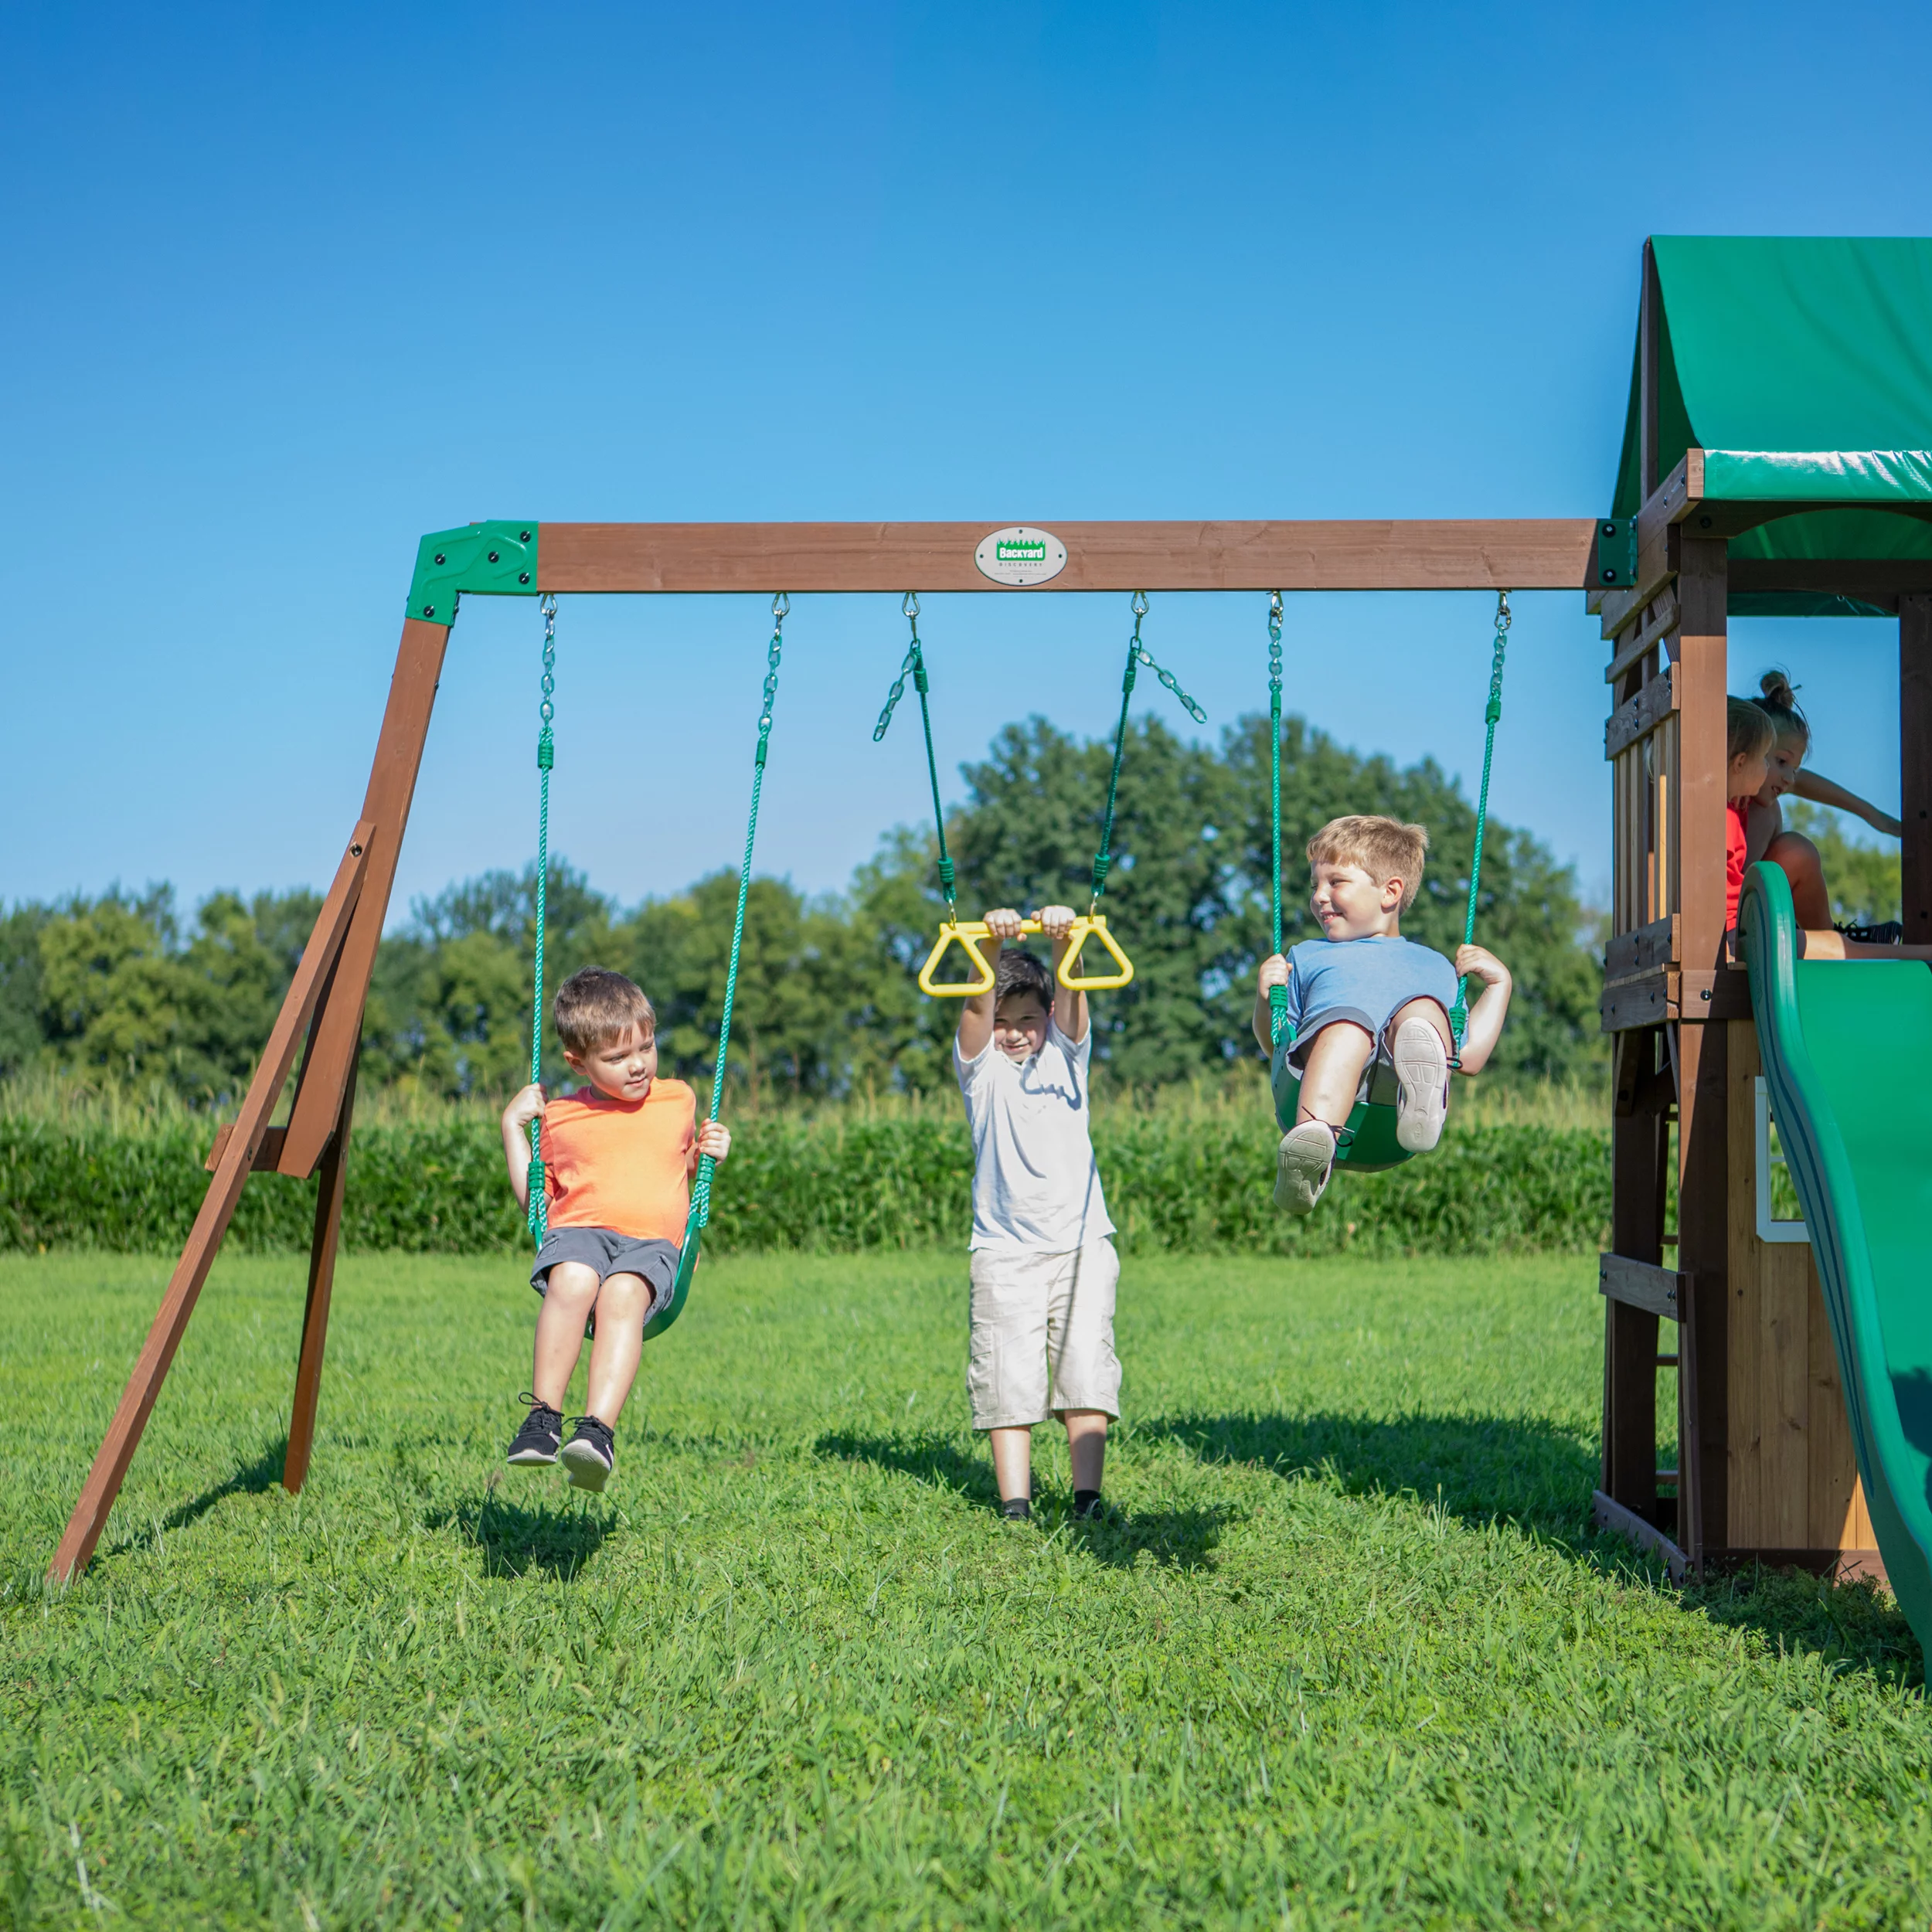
[966,1240,1121,1430]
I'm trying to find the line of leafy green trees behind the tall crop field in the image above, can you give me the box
[0,717,1600,1105]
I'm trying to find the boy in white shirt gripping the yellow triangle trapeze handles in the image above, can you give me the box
[953,906,1121,1522]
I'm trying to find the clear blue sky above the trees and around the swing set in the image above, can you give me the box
[0,4,1932,914]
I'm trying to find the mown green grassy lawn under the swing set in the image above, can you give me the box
[0,1256,1932,1928]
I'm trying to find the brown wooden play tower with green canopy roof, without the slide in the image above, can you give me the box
[1590,238,1932,1575]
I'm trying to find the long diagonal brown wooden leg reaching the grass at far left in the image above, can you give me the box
[49,819,375,1583]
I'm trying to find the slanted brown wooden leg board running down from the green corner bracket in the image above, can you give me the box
[281,618,451,1175]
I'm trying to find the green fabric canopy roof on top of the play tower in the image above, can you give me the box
[1611,236,1932,613]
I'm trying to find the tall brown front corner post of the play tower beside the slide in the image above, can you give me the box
[1673,537,1730,1565]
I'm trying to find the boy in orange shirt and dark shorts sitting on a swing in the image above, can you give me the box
[502,966,730,1490]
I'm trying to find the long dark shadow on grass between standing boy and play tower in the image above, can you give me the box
[1132,1413,1598,1546]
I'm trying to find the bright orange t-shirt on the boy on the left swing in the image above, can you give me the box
[541,1080,698,1243]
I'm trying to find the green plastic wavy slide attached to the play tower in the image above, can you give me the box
[1737,866,1932,1654]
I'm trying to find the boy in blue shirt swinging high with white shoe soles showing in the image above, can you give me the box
[1254,815,1511,1216]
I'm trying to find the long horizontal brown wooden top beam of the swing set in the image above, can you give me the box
[537,518,1596,594]
